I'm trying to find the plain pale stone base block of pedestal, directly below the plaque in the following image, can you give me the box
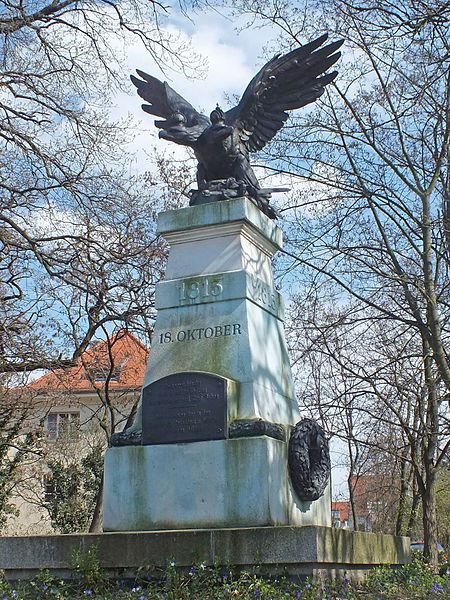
[103,436,331,531]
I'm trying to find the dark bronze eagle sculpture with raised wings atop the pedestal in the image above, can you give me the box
[131,34,343,218]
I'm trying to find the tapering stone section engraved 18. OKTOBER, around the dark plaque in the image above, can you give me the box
[139,299,299,424]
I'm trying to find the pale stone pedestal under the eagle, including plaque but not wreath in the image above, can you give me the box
[104,198,331,531]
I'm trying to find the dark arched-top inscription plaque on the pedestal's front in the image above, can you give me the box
[142,373,227,444]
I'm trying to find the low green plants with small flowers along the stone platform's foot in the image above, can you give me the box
[0,546,450,600]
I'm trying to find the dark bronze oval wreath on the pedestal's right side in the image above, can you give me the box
[288,419,331,500]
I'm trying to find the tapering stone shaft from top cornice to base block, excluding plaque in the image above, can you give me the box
[123,198,300,431]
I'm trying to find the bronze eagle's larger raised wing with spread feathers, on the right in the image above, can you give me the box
[225,34,343,152]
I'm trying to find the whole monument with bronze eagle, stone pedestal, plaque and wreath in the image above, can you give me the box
[104,36,341,531]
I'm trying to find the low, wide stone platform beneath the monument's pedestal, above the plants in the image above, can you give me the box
[0,526,410,579]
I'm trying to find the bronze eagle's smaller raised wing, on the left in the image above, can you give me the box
[130,69,211,145]
